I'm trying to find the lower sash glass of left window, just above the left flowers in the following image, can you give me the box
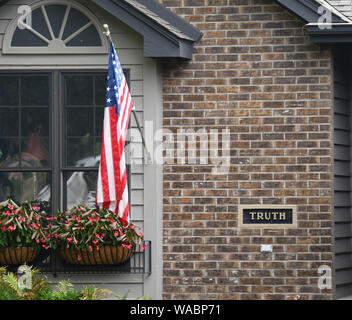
[0,172,51,203]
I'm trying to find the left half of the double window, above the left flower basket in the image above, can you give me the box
[0,74,52,210]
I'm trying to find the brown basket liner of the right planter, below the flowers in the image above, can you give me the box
[60,246,134,265]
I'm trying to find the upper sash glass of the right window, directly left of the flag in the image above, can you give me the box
[64,74,106,167]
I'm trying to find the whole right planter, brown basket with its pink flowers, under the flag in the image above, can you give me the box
[49,205,147,266]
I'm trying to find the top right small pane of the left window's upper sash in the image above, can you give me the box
[21,76,49,106]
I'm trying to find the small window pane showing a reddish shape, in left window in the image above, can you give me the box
[21,134,49,168]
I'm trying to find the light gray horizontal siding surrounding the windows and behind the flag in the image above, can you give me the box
[0,0,144,298]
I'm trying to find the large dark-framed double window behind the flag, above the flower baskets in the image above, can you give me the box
[0,70,130,212]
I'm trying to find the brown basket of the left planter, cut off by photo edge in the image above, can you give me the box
[0,247,39,266]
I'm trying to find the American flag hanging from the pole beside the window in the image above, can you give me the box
[97,43,133,223]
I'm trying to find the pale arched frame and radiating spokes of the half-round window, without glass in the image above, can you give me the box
[2,0,109,55]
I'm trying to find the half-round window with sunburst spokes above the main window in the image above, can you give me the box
[3,1,108,54]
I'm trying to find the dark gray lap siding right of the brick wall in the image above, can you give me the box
[334,50,352,299]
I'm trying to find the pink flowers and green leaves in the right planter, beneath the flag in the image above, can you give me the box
[49,205,143,252]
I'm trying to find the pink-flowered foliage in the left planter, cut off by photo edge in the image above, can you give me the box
[0,200,49,249]
